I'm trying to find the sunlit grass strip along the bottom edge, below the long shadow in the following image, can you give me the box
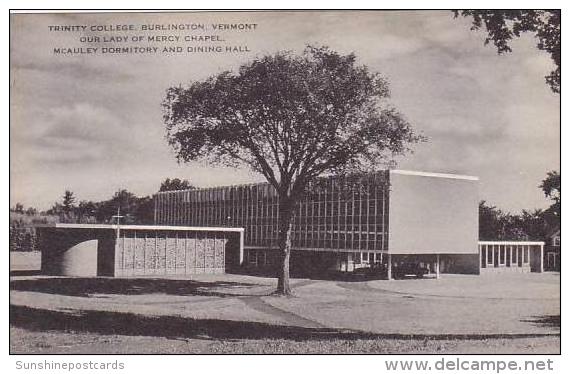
[10,327,560,354]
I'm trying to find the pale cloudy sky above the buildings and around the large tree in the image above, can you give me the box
[10,11,560,212]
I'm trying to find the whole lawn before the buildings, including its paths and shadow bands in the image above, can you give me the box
[10,251,560,354]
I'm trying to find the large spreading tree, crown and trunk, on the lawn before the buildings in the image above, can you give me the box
[163,46,423,294]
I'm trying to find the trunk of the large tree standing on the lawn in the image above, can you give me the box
[277,198,295,295]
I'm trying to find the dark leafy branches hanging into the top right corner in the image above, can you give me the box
[454,9,561,93]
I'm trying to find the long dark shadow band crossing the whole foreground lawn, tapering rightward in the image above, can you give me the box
[10,305,560,341]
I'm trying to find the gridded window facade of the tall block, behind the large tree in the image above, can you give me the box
[155,172,389,252]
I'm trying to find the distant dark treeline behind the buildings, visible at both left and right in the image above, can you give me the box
[10,171,560,251]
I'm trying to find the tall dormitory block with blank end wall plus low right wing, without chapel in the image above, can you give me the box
[155,170,542,277]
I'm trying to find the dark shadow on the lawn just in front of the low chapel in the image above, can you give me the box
[10,277,259,297]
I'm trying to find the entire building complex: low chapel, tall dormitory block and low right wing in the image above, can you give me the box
[37,170,544,278]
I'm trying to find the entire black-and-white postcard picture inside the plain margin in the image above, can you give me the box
[9,10,562,358]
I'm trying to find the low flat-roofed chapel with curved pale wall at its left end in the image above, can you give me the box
[37,223,244,278]
